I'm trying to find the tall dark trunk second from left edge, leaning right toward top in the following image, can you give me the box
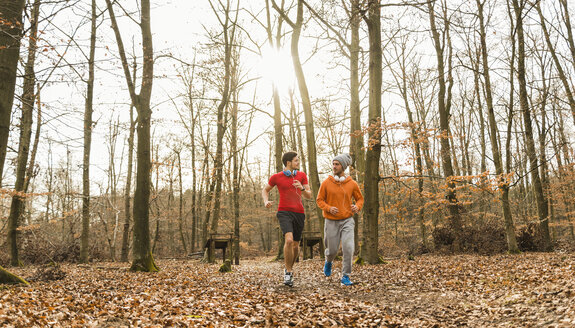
[8,0,40,266]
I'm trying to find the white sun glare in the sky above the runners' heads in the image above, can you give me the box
[258,47,295,94]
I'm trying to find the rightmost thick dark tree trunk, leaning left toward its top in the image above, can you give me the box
[512,0,553,251]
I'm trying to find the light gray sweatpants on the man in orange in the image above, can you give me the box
[323,217,355,276]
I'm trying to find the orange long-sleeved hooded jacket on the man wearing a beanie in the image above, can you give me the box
[316,175,363,220]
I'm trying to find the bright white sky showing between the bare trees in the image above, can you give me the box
[6,0,568,202]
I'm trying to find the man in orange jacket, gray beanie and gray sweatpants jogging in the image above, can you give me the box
[316,154,363,286]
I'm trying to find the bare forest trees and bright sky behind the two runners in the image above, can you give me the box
[0,0,575,271]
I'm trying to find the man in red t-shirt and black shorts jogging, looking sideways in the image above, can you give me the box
[262,151,311,287]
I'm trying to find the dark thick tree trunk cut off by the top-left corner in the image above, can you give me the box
[0,0,26,187]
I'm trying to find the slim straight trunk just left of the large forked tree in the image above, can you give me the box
[80,0,97,263]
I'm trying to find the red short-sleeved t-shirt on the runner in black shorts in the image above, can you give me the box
[268,171,308,213]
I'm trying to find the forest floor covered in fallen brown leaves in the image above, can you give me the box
[0,253,575,327]
